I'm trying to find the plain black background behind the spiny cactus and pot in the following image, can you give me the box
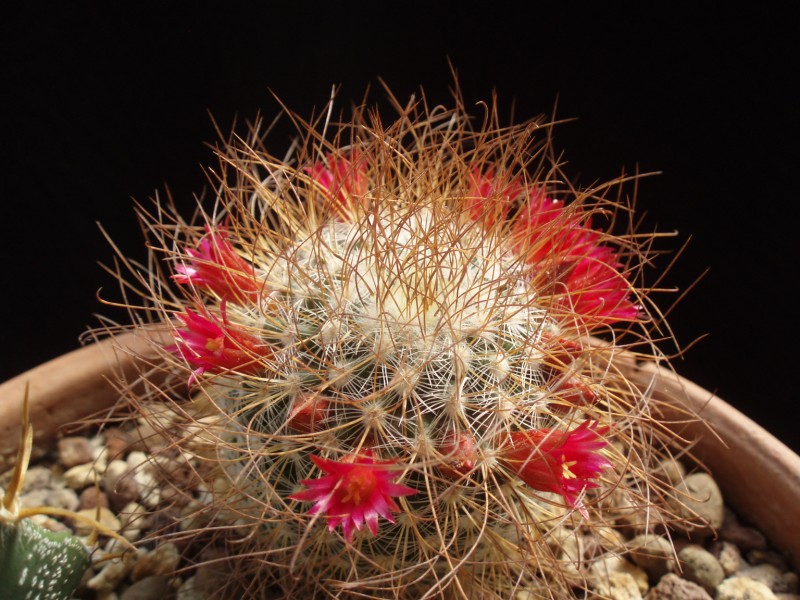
[0,2,800,450]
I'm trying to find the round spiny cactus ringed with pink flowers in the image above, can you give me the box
[109,90,692,598]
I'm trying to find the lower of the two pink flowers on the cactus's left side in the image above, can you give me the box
[169,308,272,385]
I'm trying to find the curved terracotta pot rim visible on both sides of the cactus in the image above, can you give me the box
[0,333,800,568]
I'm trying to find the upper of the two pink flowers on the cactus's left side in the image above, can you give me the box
[172,227,261,302]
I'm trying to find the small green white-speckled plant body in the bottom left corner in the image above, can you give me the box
[0,519,89,600]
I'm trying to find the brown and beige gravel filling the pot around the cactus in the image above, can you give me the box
[0,429,800,600]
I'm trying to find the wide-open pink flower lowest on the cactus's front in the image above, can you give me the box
[289,451,416,542]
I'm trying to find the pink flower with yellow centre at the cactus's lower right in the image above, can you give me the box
[500,420,611,515]
